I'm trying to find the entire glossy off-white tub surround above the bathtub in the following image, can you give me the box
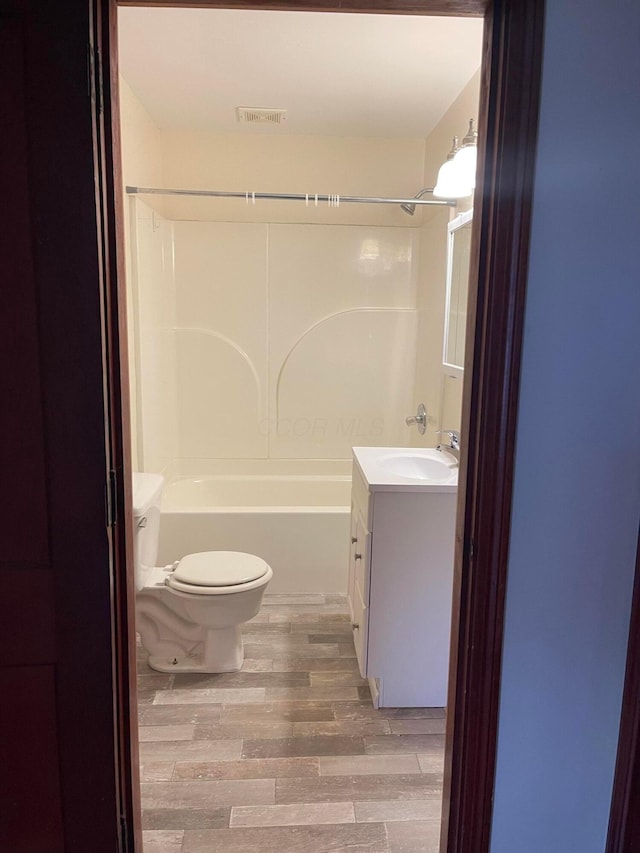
[132,199,418,470]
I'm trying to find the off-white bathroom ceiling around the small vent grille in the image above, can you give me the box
[118,7,482,137]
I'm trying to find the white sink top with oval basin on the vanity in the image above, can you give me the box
[353,447,458,492]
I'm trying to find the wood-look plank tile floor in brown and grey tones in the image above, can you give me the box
[138,594,445,853]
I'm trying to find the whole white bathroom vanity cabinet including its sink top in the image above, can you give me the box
[348,447,458,708]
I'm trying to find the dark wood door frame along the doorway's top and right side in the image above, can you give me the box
[101,0,544,853]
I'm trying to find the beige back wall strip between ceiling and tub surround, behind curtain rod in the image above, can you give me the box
[162,131,425,227]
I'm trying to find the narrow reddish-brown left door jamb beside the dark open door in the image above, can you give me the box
[91,0,142,851]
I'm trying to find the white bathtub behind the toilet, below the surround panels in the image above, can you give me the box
[158,465,351,594]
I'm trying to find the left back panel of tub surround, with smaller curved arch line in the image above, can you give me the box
[173,222,268,459]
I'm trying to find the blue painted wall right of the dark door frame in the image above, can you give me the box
[491,0,640,853]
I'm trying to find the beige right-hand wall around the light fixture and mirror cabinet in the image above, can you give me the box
[410,71,480,447]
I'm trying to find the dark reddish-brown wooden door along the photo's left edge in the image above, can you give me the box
[0,0,135,853]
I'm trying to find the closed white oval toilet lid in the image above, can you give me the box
[173,551,269,587]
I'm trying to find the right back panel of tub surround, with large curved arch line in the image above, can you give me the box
[268,225,418,459]
